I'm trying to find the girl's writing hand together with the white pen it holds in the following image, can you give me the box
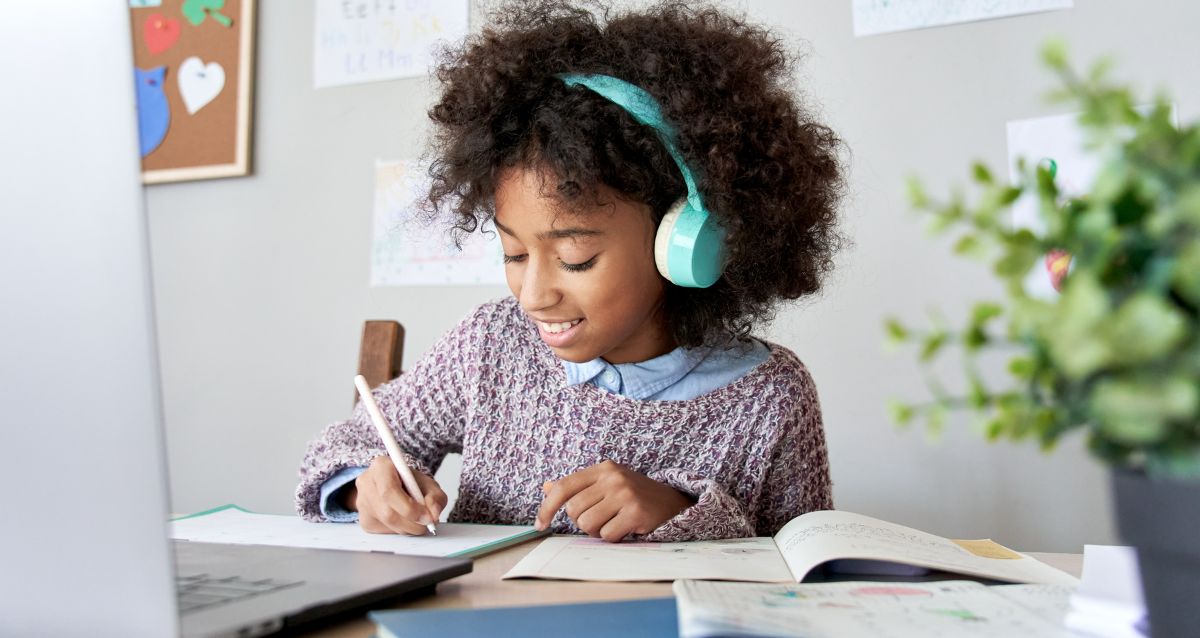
[346,375,448,536]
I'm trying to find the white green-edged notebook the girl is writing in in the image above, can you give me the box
[170,505,548,558]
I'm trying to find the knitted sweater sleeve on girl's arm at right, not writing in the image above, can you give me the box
[642,368,833,541]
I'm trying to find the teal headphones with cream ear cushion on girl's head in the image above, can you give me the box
[557,73,725,288]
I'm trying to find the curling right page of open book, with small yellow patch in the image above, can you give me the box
[775,510,1079,586]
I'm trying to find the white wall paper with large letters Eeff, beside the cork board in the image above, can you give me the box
[314,0,468,89]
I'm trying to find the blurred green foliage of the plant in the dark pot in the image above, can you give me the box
[886,42,1200,480]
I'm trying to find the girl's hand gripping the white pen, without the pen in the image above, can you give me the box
[346,456,448,536]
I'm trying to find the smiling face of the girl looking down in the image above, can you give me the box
[496,169,674,363]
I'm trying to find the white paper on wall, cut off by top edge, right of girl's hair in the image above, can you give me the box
[854,0,1074,37]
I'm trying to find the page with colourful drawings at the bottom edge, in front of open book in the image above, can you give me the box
[673,580,1070,638]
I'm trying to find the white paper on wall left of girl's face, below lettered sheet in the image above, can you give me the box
[371,160,504,285]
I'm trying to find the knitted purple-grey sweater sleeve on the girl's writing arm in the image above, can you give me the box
[295,309,482,520]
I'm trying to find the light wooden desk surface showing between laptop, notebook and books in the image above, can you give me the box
[306,541,1084,638]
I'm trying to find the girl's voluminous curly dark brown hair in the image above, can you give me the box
[428,0,845,347]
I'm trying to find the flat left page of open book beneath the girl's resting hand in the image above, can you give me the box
[504,536,792,583]
